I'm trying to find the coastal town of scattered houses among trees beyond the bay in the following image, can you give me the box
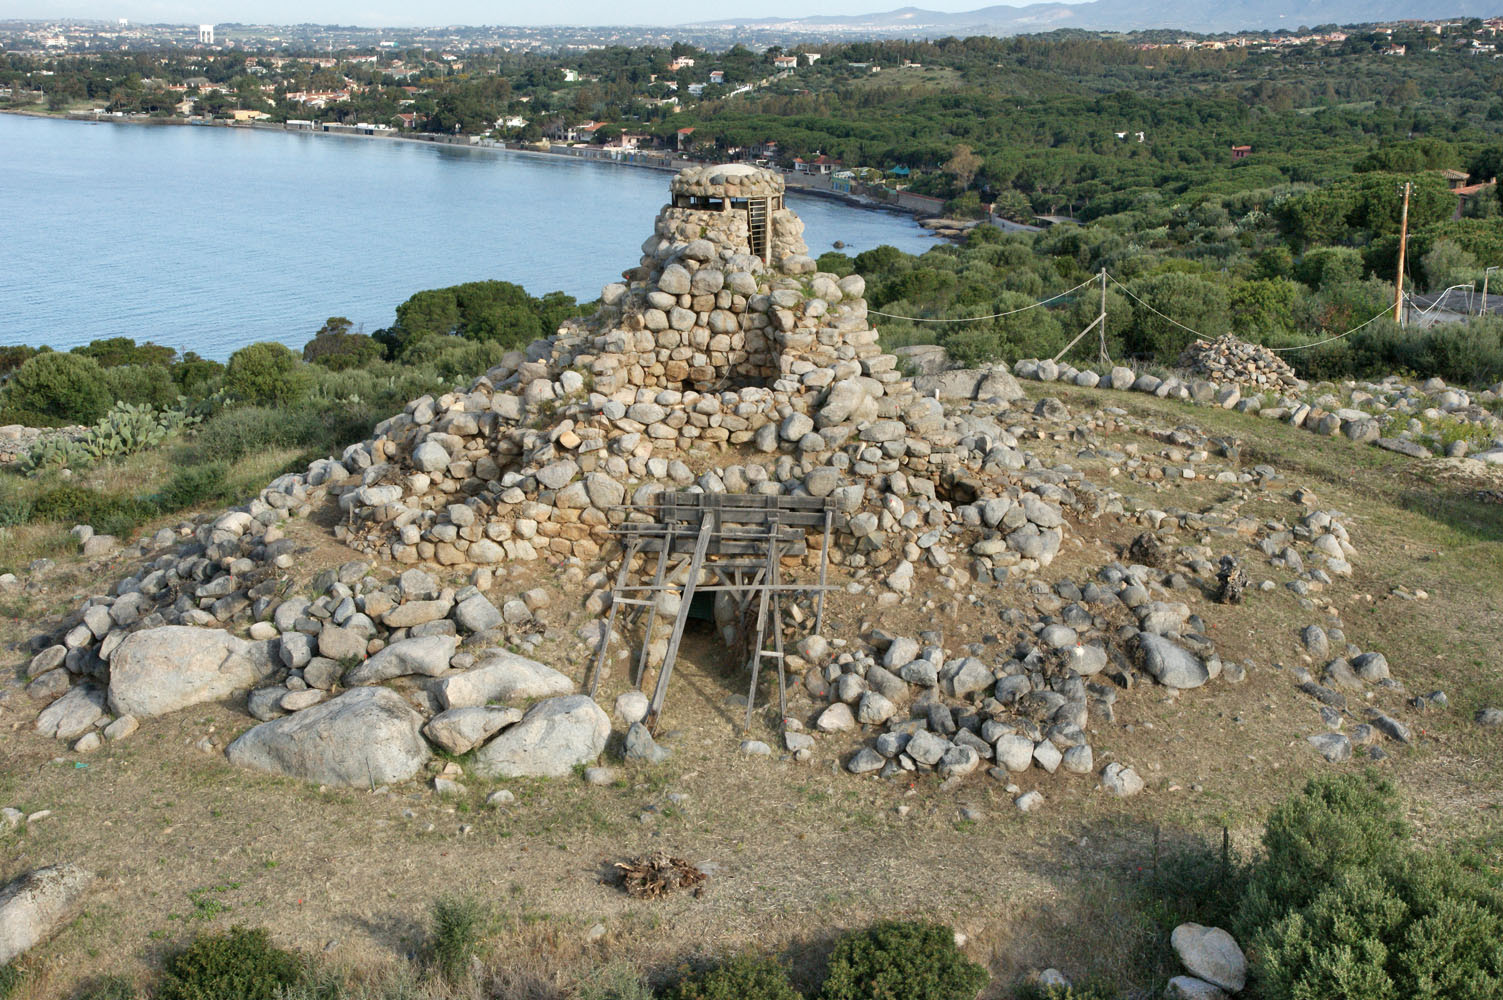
[0,18,1503,236]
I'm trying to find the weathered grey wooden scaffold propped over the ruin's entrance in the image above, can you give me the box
[589,493,834,729]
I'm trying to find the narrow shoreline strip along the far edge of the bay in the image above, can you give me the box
[0,108,945,228]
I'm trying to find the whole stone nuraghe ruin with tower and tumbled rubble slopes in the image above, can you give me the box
[17,165,1401,808]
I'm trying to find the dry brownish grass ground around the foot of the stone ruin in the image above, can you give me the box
[0,378,1503,1000]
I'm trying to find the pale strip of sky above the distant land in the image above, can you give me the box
[0,0,1076,27]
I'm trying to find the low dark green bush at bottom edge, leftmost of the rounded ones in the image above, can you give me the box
[156,926,304,1000]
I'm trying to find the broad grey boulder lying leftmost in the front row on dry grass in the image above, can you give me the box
[224,687,431,788]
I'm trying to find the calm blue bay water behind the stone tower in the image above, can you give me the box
[0,114,933,359]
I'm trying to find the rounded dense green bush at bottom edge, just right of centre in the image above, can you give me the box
[819,920,987,1000]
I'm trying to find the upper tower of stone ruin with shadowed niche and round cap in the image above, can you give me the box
[568,164,885,394]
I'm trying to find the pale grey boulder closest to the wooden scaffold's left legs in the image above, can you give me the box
[472,695,610,779]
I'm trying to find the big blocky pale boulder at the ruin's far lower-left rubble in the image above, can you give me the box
[110,626,281,719]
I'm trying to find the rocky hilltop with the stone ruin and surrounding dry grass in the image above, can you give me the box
[0,167,1503,1000]
